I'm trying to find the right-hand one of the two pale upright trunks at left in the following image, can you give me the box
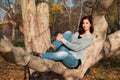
[36,2,51,53]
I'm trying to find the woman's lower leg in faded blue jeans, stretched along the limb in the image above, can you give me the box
[41,51,78,68]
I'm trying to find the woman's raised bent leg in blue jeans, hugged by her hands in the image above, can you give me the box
[53,31,72,49]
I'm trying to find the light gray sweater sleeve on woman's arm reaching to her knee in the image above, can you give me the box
[63,36,93,51]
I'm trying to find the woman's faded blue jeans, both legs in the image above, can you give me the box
[41,31,79,68]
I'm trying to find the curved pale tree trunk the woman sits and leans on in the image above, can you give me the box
[0,0,120,80]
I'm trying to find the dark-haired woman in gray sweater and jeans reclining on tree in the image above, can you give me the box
[33,16,93,68]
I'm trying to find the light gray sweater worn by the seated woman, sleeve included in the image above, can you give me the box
[63,32,93,64]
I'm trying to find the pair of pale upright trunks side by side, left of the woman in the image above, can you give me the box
[21,0,50,53]
